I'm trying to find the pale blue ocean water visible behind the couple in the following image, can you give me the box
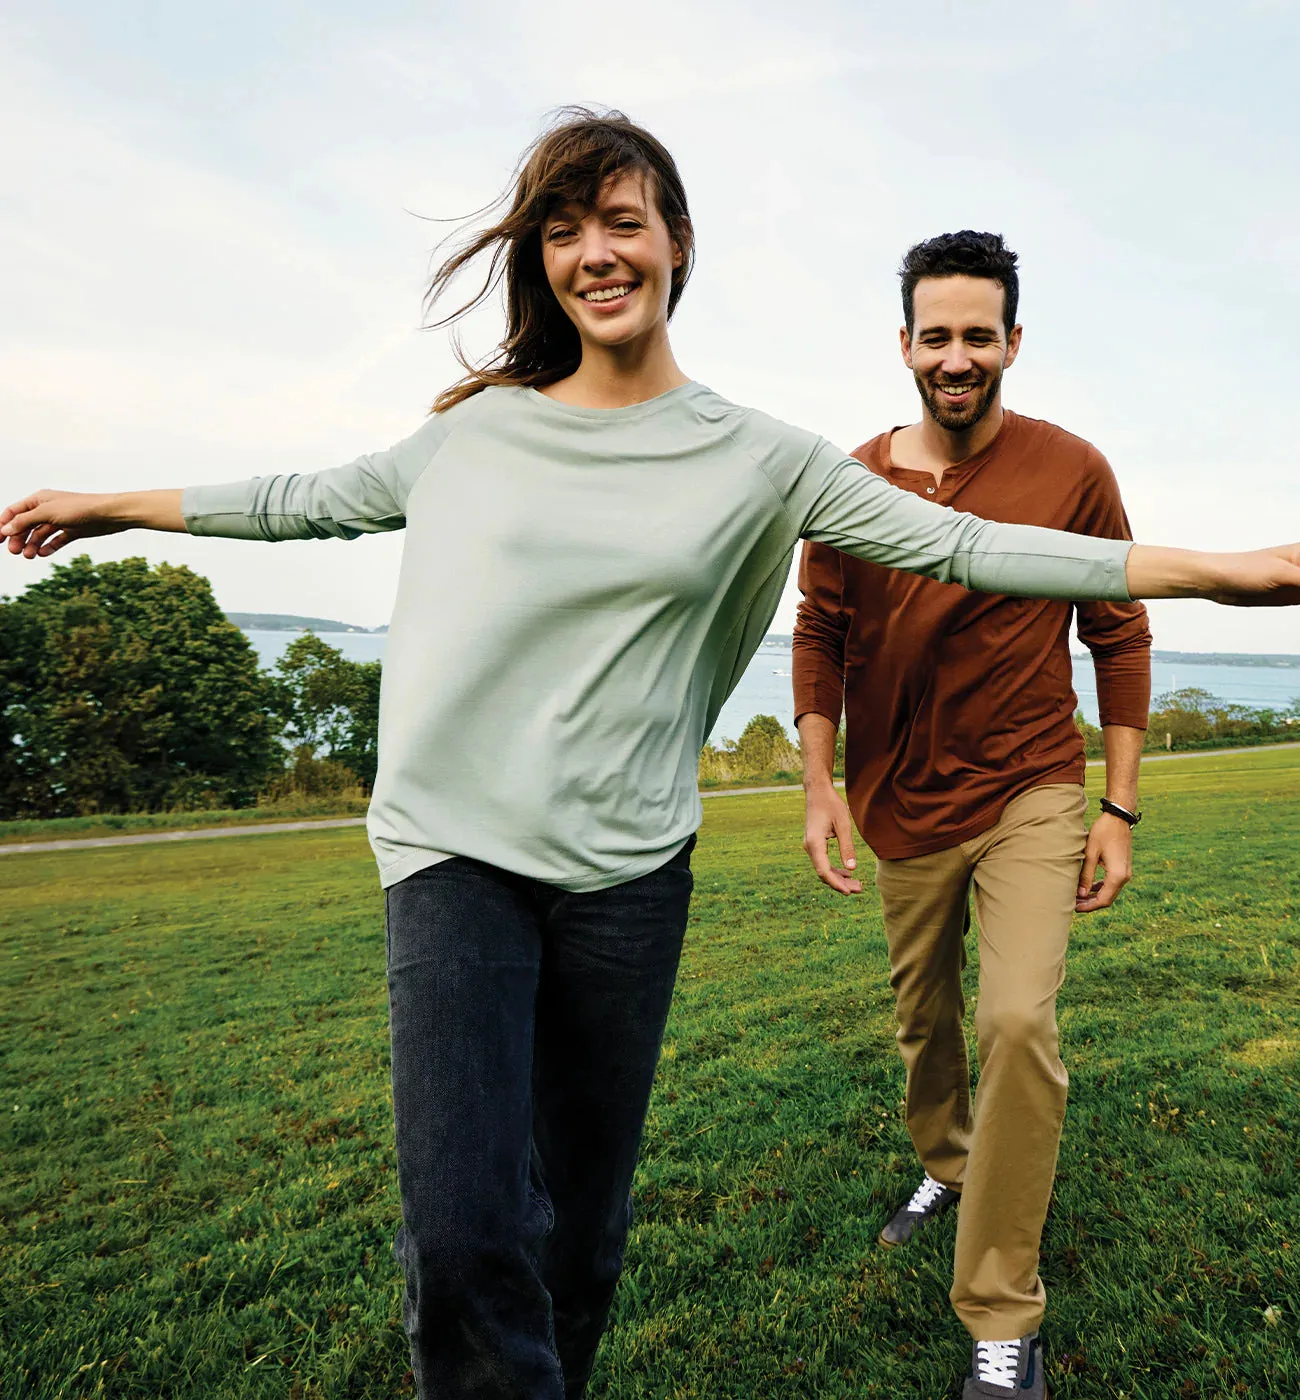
[248,631,1300,743]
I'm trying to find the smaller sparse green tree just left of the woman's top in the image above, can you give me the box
[276,631,382,787]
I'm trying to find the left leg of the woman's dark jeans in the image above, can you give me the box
[388,858,563,1400]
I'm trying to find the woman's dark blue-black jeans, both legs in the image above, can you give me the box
[388,839,694,1400]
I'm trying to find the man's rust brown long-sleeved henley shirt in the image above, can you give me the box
[793,412,1152,860]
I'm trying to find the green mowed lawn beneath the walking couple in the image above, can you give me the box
[0,750,1300,1400]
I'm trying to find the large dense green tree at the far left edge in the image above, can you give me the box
[0,554,284,818]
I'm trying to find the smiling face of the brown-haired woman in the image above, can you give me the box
[542,171,683,349]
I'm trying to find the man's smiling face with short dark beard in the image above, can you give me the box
[901,277,1020,433]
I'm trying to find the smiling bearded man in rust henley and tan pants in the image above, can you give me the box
[793,230,1150,1400]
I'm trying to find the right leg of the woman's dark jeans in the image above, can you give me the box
[533,840,694,1400]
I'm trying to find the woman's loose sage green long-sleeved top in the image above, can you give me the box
[183,382,1131,890]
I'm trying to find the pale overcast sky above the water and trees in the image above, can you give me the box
[0,0,1300,651]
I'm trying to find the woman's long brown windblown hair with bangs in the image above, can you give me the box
[424,106,694,413]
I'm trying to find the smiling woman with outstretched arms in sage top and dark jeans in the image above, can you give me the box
[0,109,1300,1400]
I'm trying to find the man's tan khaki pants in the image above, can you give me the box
[876,783,1087,1341]
